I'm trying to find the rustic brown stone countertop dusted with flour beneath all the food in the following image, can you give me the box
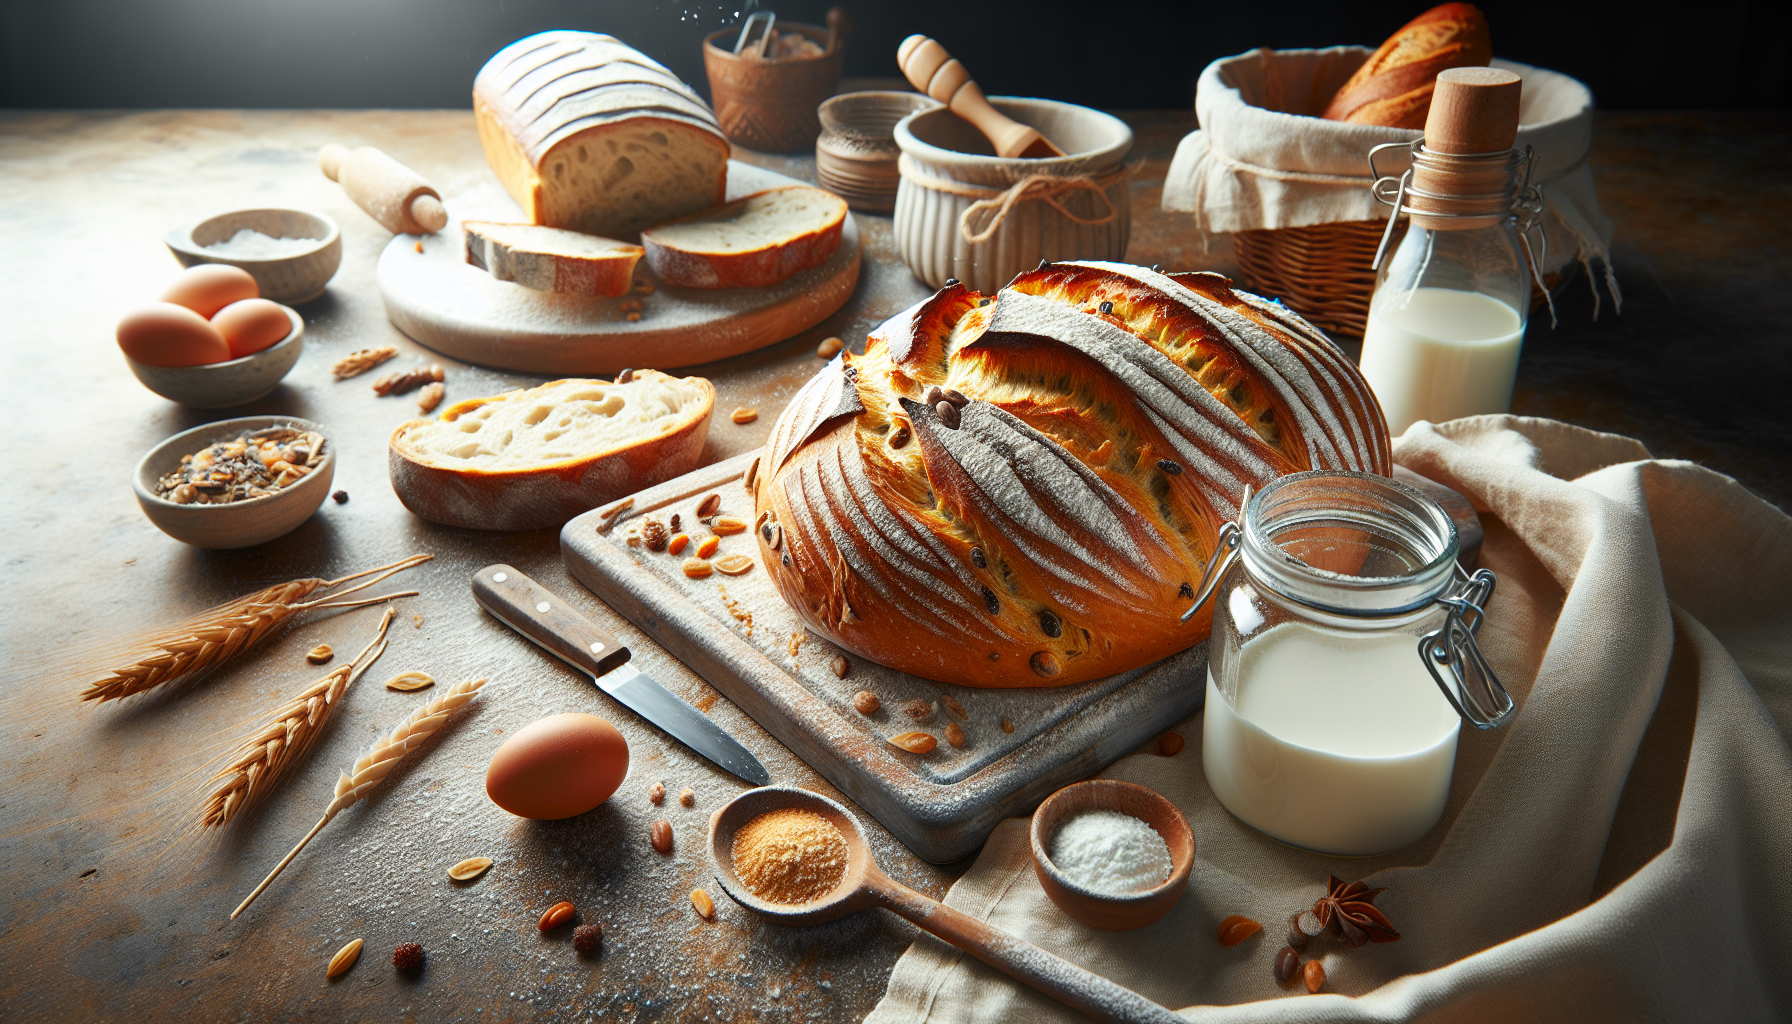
[0,111,1792,1022]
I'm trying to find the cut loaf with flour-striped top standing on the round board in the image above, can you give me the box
[473,32,729,242]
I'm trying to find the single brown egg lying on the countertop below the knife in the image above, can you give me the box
[486,712,629,821]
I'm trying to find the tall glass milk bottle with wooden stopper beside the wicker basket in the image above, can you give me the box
[1362,68,1538,436]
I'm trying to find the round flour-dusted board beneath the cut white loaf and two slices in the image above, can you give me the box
[378,160,858,377]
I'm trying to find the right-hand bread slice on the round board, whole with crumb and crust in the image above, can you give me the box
[642,185,846,289]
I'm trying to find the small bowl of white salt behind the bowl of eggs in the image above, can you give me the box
[163,208,342,305]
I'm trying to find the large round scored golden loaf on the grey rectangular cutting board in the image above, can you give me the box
[753,264,1392,687]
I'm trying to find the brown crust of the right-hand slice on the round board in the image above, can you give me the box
[642,185,846,289]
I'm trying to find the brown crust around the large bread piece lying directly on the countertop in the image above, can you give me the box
[387,369,715,529]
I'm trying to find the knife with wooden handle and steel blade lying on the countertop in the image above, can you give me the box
[473,565,772,785]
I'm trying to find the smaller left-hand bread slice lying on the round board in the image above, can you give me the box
[461,221,643,298]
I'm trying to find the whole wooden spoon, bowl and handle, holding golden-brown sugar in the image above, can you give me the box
[710,785,1183,1024]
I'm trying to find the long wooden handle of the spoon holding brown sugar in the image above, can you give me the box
[871,877,1183,1024]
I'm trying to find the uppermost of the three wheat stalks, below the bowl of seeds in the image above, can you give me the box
[81,554,434,703]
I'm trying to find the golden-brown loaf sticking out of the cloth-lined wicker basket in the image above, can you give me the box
[1321,4,1493,129]
